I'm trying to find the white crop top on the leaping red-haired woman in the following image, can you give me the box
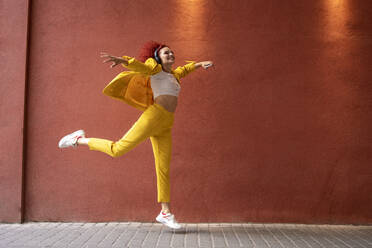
[151,70,181,99]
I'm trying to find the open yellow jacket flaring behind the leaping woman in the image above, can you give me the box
[103,56,196,111]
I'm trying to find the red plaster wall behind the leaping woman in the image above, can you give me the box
[0,0,372,224]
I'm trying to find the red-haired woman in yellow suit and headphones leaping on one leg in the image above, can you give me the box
[59,41,213,229]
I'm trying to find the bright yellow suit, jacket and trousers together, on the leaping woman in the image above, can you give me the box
[88,56,195,202]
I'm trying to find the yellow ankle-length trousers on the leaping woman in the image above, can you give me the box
[88,103,174,202]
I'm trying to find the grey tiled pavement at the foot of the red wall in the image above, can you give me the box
[0,222,372,248]
